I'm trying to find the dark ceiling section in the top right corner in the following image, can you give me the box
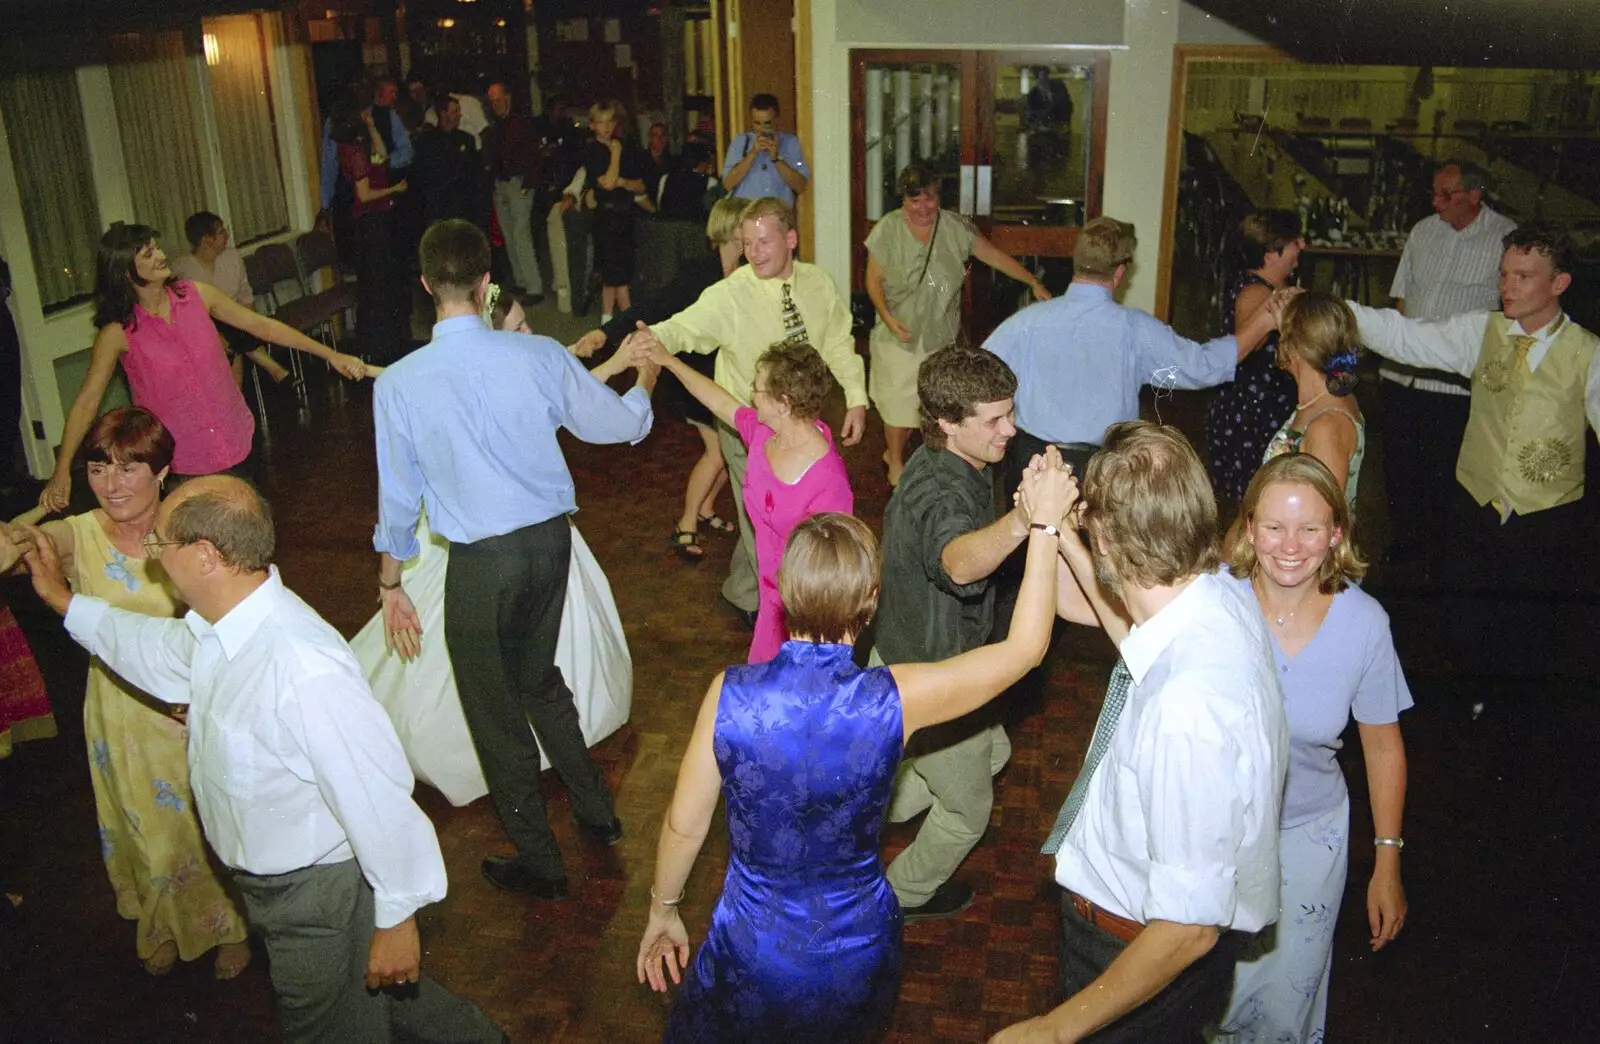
[1189,0,1600,70]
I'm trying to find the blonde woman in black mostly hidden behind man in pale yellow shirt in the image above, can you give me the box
[573,197,750,562]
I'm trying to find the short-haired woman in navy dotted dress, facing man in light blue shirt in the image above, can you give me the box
[1205,210,1306,501]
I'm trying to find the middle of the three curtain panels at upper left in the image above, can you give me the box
[109,32,208,256]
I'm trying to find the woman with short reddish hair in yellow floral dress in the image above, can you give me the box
[0,407,250,978]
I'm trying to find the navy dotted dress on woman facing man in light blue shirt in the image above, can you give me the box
[1205,272,1294,500]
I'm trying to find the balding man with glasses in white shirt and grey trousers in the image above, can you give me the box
[18,476,504,1044]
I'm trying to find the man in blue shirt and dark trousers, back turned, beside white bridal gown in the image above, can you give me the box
[373,219,656,900]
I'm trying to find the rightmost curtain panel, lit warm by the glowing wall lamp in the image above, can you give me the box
[203,14,290,243]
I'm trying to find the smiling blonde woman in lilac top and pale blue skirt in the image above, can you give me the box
[1216,453,1411,1044]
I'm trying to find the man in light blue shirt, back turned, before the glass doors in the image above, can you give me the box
[984,218,1274,492]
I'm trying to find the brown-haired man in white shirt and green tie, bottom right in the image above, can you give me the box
[990,421,1288,1044]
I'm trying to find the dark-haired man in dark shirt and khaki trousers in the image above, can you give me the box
[872,347,1027,921]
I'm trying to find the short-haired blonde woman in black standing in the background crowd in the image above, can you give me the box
[582,101,648,322]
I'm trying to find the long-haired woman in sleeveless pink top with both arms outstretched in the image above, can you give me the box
[38,221,366,511]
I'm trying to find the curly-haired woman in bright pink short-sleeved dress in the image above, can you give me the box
[646,343,856,663]
